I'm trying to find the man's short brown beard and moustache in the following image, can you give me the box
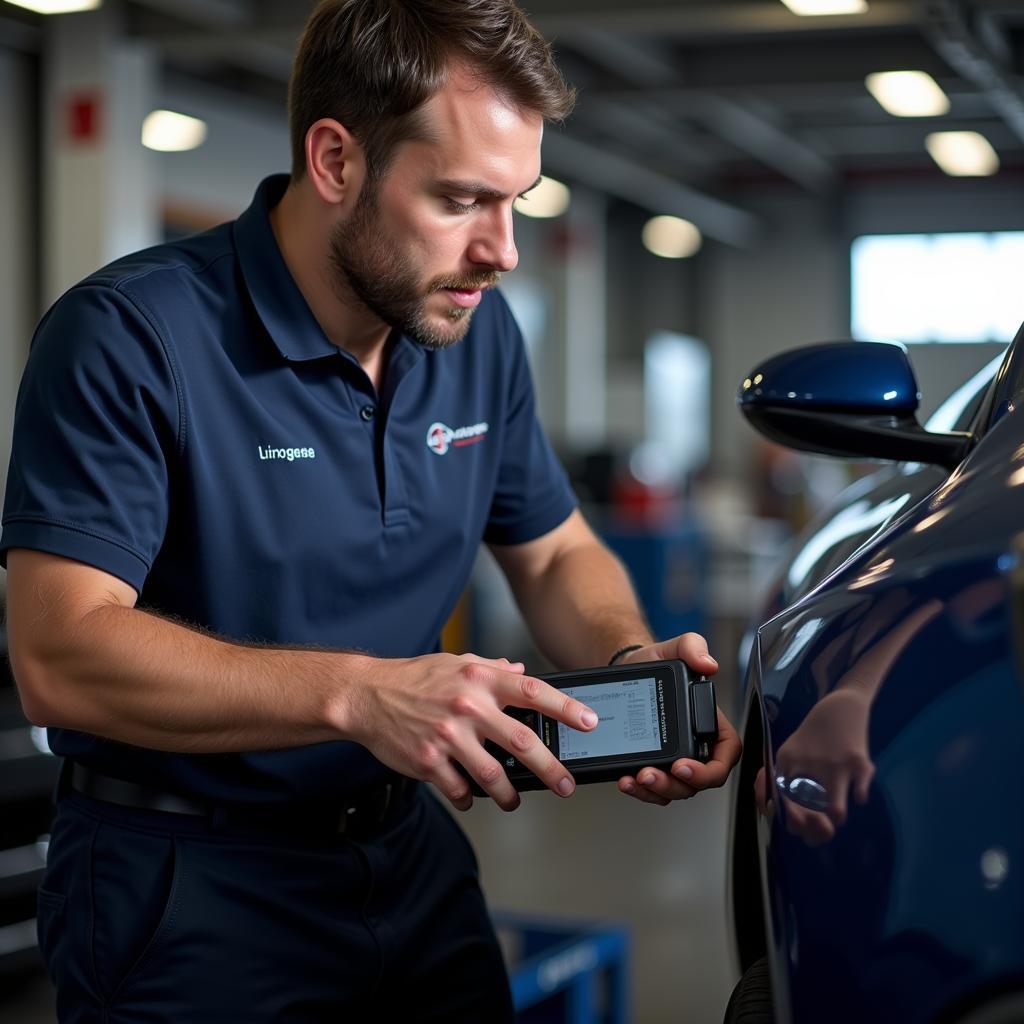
[329,180,498,350]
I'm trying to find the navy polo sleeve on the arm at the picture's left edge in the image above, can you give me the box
[0,284,181,591]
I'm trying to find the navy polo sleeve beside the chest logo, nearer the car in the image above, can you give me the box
[483,302,578,544]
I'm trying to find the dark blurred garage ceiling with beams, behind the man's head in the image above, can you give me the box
[6,0,1024,245]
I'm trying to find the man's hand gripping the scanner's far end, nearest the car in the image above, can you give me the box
[616,633,742,807]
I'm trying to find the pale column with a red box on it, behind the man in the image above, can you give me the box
[43,4,160,303]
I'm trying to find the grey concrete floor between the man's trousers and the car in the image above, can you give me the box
[459,770,736,1024]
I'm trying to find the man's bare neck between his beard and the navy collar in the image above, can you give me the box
[270,184,390,391]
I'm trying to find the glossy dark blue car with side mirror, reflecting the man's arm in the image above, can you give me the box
[726,328,1024,1024]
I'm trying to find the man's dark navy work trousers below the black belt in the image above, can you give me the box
[39,786,513,1024]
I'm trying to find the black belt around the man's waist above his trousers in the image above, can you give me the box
[67,762,416,836]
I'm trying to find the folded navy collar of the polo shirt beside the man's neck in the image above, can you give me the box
[234,174,340,361]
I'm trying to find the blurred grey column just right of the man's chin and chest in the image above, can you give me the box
[563,188,607,449]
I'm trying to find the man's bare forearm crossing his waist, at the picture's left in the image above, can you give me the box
[11,604,362,753]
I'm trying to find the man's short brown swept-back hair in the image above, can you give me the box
[288,0,575,179]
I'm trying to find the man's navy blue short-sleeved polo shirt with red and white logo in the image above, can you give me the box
[0,175,574,802]
